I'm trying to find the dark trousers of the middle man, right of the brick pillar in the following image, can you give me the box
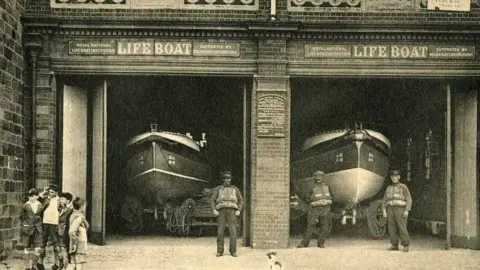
[301,205,332,247]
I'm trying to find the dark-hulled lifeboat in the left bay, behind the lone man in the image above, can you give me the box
[121,125,211,230]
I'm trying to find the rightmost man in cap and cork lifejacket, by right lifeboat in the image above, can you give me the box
[382,170,412,252]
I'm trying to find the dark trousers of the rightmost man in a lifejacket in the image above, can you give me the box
[387,206,410,246]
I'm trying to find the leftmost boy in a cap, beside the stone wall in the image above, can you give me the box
[20,188,43,270]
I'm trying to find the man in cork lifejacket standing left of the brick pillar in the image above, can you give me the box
[211,171,243,257]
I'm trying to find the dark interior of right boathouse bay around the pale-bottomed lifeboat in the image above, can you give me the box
[291,78,458,236]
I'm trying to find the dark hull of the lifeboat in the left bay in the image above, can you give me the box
[127,141,210,205]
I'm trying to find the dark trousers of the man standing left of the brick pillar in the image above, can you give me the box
[217,208,237,253]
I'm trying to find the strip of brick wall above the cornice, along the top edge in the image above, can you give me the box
[26,0,480,27]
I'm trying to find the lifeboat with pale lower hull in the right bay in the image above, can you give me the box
[291,125,391,237]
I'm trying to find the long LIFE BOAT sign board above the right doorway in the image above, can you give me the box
[305,44,475,59]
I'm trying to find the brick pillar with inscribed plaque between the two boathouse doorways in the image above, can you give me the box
[251,39,290,249]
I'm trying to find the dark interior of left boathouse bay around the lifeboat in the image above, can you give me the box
[107,76,251,234]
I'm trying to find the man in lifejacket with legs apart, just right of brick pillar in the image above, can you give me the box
[298,171,332,248]
